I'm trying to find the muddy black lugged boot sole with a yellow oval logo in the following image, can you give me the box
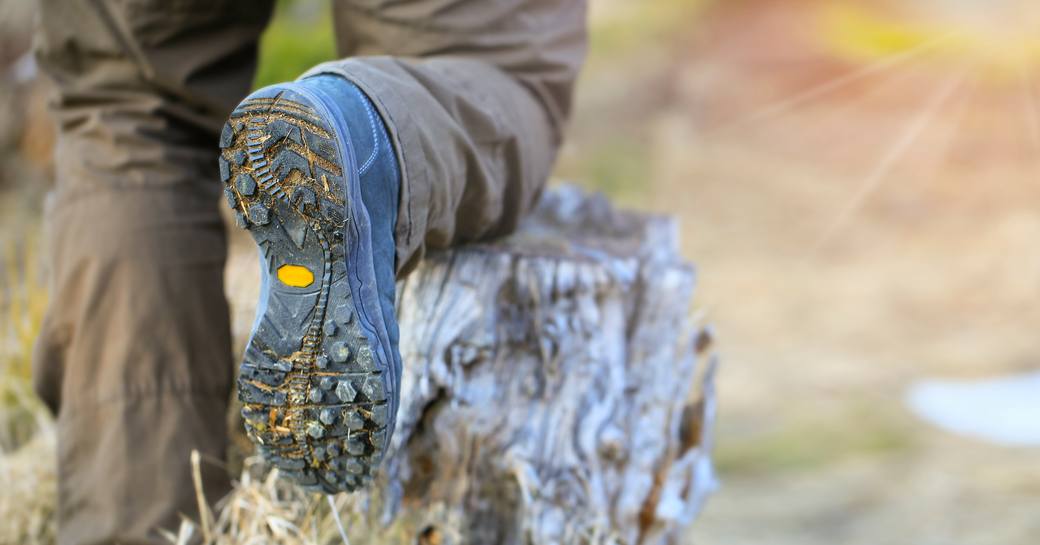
[219,90,396,493]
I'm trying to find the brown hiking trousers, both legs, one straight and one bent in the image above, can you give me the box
[35,0,586,545]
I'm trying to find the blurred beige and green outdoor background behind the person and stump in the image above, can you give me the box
[0,0,1040,545]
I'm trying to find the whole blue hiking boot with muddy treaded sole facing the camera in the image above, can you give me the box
[219,75,401,493]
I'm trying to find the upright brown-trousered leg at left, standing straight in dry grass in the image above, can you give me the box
[34,0,271,544]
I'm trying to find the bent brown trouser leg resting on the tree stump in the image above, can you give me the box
[310,0,587,271]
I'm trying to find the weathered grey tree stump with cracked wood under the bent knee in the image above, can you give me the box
[341,187,716,545]
